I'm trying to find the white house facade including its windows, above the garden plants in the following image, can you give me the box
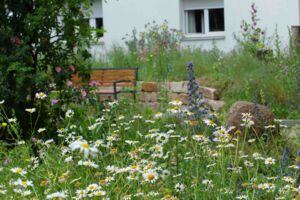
[88,0,300,57]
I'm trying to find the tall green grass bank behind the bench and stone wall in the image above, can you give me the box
[93,46,300,118]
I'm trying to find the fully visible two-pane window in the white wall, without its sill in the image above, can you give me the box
[184,8,225,34]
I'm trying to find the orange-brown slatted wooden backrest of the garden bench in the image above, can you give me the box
[72,67,138,87]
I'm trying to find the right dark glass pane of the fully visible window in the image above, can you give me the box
[209,8,225,32]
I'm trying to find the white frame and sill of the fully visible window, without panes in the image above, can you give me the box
[183,6,226,39]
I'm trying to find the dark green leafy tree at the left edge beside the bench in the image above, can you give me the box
[0,0,96,139]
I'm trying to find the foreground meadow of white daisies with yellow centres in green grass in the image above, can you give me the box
[0,86,300,200]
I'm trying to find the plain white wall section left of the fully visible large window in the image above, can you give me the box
[103,0,180,46]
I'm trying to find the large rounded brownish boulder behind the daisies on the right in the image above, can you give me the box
[227,101,274,134]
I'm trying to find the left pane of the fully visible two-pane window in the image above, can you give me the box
[187,10,204,33]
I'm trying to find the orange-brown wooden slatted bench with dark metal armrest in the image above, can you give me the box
[71,67,138,100]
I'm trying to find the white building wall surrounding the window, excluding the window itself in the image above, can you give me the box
[94,0,300,56]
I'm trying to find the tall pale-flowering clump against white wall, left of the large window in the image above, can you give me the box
[124,21,182,79]
